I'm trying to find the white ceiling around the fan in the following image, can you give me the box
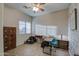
[5,3,69,16]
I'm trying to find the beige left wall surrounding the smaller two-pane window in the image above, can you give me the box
[3,5,31,46]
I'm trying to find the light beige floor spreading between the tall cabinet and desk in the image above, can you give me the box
[5,43,69,56]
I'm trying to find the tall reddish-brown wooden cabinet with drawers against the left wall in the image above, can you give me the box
[3,27,16,51]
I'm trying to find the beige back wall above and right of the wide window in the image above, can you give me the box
[32,10,68,36]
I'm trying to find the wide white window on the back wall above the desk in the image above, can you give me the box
[35,24,57,36]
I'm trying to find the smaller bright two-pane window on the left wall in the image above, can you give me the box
[19,21,31,34]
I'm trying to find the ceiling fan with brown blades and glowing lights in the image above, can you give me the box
[24,3,45,13]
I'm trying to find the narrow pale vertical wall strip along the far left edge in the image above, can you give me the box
[0,3,3,56]
